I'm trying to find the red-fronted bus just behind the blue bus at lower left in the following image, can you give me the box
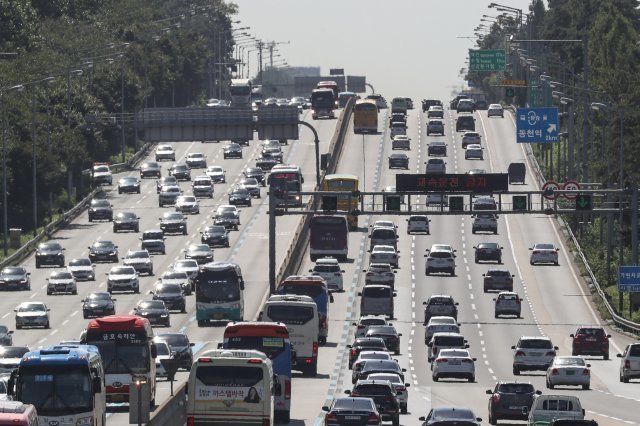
[81,314,157,406]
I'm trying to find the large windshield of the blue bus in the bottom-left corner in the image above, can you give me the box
[18,365,93,416]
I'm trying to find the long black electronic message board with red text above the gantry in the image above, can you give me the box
[396,173,509,193]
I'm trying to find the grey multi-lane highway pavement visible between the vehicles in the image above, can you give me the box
[5,98,640,425]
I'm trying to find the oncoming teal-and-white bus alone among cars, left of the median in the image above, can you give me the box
[194,261,244,327]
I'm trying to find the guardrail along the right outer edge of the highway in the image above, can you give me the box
[510,107,640,334]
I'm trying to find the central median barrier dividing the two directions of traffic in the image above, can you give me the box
[148,99,355,426]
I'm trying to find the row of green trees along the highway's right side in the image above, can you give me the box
[467,0,640,319]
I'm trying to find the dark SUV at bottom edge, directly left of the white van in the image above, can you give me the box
[487,381,536,425]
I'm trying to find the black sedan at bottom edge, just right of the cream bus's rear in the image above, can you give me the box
[322,397,382,426]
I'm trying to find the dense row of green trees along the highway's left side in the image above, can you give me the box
[0,0,237,230]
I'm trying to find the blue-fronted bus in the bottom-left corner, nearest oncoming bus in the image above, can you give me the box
[9,345,107,426]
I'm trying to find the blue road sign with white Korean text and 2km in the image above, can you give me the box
[516,108,559,143]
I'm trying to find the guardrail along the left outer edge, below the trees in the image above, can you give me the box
[0,143,153,269]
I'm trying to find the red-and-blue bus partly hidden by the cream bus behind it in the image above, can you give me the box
[221,322,295,423]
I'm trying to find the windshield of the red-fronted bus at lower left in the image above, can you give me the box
[87,340,149,374]
